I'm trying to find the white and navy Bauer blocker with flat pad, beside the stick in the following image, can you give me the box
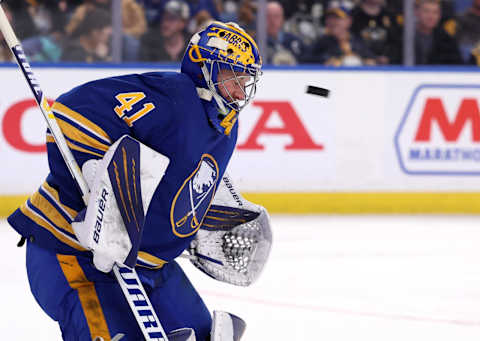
[72,135,169,272]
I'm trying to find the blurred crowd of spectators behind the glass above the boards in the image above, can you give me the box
[0,0,480,66]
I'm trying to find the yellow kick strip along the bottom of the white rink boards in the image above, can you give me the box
[0,192,480,217]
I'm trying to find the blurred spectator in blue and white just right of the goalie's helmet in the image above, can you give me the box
[266,1,303,65]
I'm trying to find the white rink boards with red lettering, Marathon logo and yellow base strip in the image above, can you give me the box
[0,65,480,212]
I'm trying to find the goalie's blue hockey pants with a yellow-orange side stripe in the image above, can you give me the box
[27,243,211,341]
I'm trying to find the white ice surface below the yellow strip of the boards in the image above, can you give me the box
[0,215,480,341]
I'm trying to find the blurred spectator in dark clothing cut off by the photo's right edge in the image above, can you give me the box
[457,0,480,59]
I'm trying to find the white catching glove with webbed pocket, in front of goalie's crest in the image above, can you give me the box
[188,173,272,286]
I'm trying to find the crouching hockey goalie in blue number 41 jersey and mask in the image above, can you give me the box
[4,22,272,341]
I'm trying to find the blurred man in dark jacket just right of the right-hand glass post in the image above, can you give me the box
[415,0,463,65]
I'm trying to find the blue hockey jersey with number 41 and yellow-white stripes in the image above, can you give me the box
[8,72,238,268]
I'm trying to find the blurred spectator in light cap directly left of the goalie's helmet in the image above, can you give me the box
[140,0,190,62]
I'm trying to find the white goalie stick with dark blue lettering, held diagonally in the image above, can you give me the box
[0,0,168,341]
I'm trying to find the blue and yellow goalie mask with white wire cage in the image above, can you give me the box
[181,21,262,115]
